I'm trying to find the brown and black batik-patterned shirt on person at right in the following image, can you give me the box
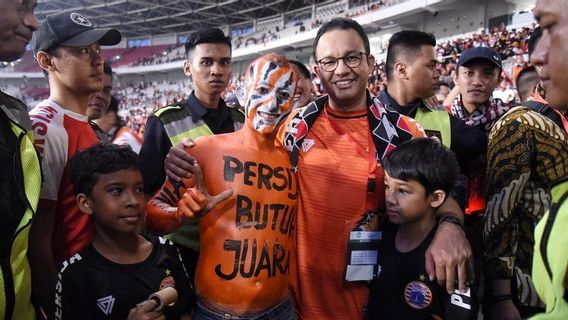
[484,107,568,306]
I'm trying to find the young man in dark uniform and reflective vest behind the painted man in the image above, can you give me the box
[140,28,245,280]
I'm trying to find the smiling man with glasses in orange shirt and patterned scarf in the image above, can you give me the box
[284,18,469,319]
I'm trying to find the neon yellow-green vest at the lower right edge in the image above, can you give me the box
[530,179,568,320]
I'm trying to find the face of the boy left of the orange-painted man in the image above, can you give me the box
[82,169,146,233]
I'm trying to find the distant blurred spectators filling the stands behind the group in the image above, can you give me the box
[106,25,535,136]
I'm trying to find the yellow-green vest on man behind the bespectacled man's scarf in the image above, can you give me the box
[414,106,452,148]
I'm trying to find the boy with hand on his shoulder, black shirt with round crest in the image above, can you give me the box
[368,139,476,320]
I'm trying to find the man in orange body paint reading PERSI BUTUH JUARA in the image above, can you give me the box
[147,53,298,319]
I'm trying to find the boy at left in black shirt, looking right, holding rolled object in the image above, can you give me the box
[55,145,194,320]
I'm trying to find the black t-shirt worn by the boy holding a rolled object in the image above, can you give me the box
[55,236,195,320]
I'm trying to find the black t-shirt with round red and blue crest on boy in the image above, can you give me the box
[367,222,477,320]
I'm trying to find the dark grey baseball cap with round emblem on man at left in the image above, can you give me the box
[32,12,122,54]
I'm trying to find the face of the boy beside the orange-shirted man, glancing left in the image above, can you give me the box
[385,172,434,224]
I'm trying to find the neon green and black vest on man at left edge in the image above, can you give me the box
[0,98,41,320]
